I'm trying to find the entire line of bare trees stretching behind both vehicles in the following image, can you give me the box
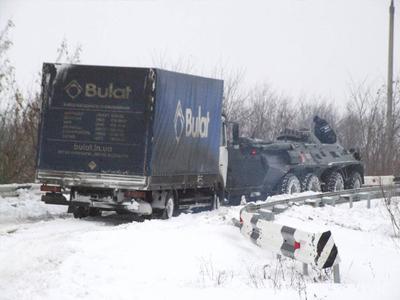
[0,21,400,183]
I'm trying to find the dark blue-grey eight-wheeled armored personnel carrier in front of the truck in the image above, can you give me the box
[227,117,364,204]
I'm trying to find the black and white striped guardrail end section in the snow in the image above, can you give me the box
[240,204,340,283]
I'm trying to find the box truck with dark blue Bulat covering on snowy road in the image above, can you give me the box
[36,63,228,219]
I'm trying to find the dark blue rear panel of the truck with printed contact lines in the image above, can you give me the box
[38,64,149,175]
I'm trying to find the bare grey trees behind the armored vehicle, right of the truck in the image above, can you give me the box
[224,72,400,175]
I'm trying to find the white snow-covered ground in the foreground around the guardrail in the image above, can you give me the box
[0,192,400,300]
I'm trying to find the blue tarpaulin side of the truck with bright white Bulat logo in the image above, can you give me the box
[150,69,223,186]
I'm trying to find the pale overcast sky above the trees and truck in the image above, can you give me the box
[0,0,400,103]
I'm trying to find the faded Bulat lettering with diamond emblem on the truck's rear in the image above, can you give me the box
[65,80,132,100]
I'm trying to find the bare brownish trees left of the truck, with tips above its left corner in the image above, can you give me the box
[0,29,81,183]
